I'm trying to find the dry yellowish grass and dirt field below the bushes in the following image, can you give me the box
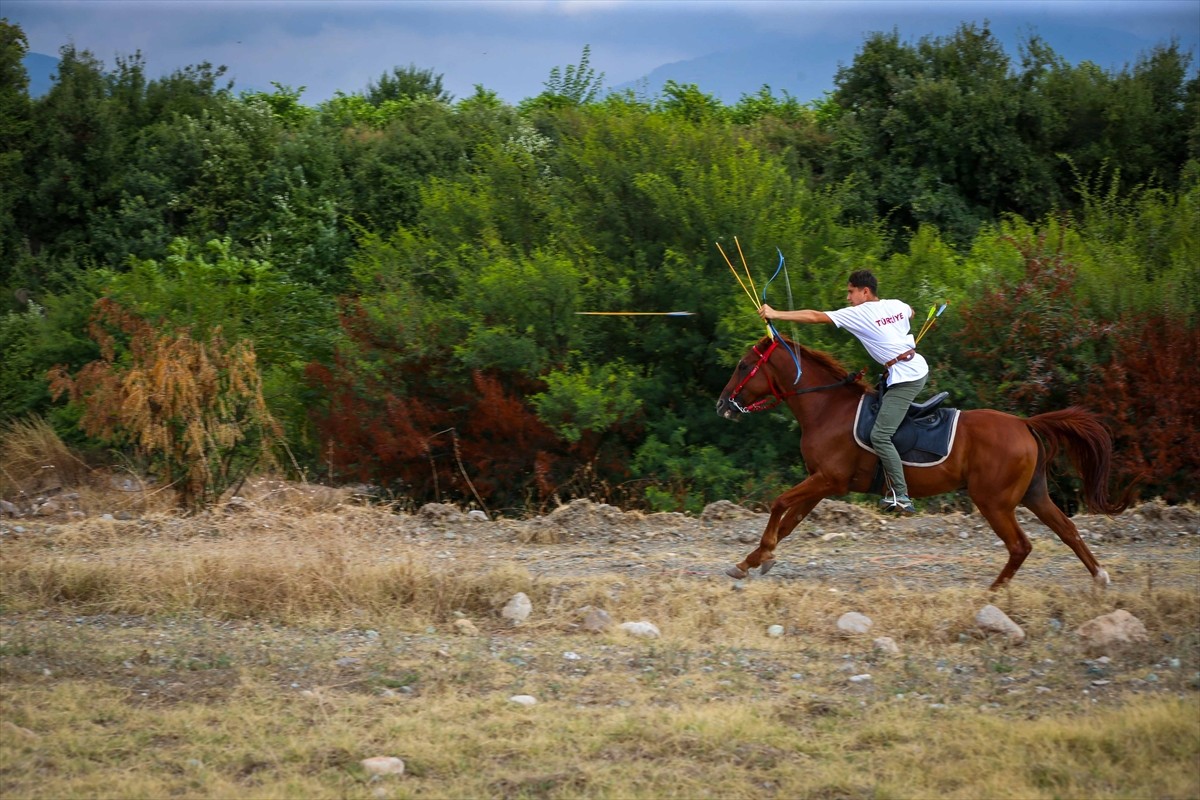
[0,474,1200,800]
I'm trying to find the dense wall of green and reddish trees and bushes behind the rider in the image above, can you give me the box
[0,23,1200,511]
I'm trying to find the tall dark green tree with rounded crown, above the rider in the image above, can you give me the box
[834,24,1052,245]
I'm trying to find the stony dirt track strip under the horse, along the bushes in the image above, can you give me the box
[0,491,1200,590]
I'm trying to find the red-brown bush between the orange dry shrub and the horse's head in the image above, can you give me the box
[307,299,588,506]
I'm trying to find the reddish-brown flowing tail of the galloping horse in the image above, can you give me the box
[1025,407,1136,515]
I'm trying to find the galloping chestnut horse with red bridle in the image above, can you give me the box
[716,337,1133,589]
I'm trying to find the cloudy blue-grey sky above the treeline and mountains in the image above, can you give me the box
[9,0,1200,103]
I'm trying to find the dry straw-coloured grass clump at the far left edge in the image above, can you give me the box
[0,416,91,497]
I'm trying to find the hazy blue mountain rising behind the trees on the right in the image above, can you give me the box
[612,23,1200,104]
